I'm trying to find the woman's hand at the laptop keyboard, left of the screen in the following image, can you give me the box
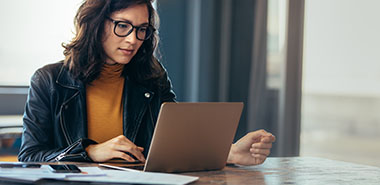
[86,135,145,162]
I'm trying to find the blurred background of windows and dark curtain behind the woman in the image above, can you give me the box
[0,0,380,166]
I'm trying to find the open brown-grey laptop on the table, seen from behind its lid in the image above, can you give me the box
[101,102,243,172]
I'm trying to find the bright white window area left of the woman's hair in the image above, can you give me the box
[0,0,81,85]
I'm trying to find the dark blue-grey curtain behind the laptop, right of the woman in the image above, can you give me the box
[158,0,299,156]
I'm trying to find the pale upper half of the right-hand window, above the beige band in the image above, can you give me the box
[303,0,380,97]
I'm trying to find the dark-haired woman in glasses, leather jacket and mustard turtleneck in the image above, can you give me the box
[18,0,275,165]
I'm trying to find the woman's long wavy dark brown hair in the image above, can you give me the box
[62,0,165,84]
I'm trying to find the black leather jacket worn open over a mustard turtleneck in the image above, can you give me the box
[18,62,175,162]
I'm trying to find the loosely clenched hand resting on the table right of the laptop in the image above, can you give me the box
[227,130,276,165]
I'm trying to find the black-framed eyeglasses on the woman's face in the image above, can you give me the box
[108,18,156,41]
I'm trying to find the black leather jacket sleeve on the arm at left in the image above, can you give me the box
[18,69,95,162]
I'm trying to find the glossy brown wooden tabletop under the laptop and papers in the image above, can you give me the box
[0,157,380,185]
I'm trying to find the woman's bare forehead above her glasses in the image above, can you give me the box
[111,4,149,25]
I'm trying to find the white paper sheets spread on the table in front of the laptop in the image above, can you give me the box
[0,165,199,185]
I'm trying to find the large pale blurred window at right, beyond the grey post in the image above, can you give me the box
[300,0,380,166]
